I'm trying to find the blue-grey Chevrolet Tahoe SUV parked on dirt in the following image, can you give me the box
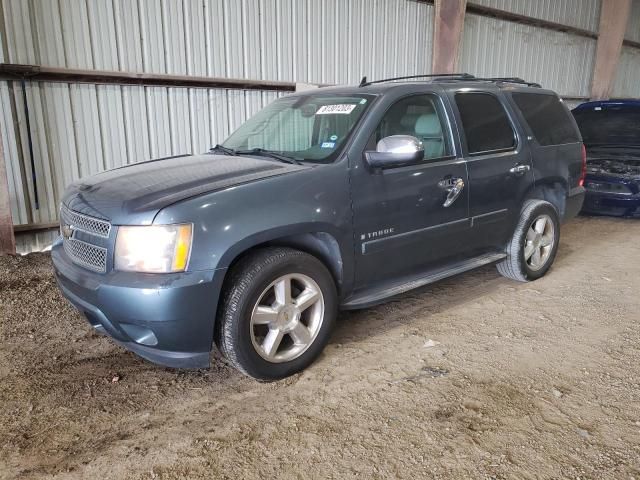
[52,74,585,380]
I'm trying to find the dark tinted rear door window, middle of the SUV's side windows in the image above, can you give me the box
[455,92,516,154]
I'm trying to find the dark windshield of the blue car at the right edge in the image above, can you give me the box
[573,105,640,146]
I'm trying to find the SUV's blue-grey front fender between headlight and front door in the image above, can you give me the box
[154,162,354,292]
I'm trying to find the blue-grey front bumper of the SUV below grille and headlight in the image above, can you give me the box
[51,242,225,368]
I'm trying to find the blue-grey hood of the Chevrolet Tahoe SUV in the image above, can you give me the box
[63,154,310,225]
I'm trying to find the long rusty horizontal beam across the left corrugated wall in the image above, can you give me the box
[0,63,296,92]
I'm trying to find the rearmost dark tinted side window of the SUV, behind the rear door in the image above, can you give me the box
[511,92,580,145]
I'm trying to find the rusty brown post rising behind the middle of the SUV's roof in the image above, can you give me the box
[431,0,467,73]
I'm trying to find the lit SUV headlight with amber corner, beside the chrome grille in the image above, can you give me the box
[115,224,193,273]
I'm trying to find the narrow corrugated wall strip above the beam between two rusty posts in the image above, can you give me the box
[469,0,601,32]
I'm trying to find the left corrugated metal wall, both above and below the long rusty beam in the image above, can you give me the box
[0,0,433,238]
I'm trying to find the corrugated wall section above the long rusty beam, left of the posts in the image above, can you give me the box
[1,0,433,83]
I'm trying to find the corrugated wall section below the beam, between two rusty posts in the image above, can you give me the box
[460,13,596,96]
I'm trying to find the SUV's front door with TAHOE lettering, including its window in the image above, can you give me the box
[351,94,470,289]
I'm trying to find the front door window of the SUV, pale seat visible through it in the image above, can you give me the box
[374,95,451,160]
